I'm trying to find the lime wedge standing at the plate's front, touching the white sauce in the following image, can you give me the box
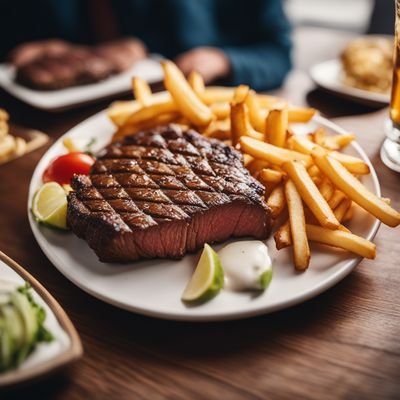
[182,243,224,302]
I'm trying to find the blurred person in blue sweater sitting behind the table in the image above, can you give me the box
[0,0,291,90]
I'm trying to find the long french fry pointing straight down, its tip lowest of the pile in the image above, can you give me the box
[285,179,310,271]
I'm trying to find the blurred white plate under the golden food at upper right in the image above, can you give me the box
[310,59,390,105]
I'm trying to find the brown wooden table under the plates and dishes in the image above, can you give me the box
[0,29,400,400]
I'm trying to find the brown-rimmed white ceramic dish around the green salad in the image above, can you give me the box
[0,252,82,388]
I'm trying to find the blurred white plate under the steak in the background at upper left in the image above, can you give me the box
[0,56,163,111]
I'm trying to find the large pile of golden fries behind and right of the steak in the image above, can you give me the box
[108,61,400,271]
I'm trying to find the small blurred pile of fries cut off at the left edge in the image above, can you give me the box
[0,108,26,164]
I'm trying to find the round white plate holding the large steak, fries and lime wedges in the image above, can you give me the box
[28,106,380,321]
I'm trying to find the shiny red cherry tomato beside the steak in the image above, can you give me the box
[42,151,94,185]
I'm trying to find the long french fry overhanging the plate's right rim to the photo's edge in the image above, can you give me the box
[312,149,400,227]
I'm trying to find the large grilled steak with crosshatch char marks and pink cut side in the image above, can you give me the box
[67,125,271,262]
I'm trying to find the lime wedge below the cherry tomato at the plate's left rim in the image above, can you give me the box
[32,182,67,229]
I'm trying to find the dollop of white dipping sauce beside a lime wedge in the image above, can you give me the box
[218,240,272,291]
